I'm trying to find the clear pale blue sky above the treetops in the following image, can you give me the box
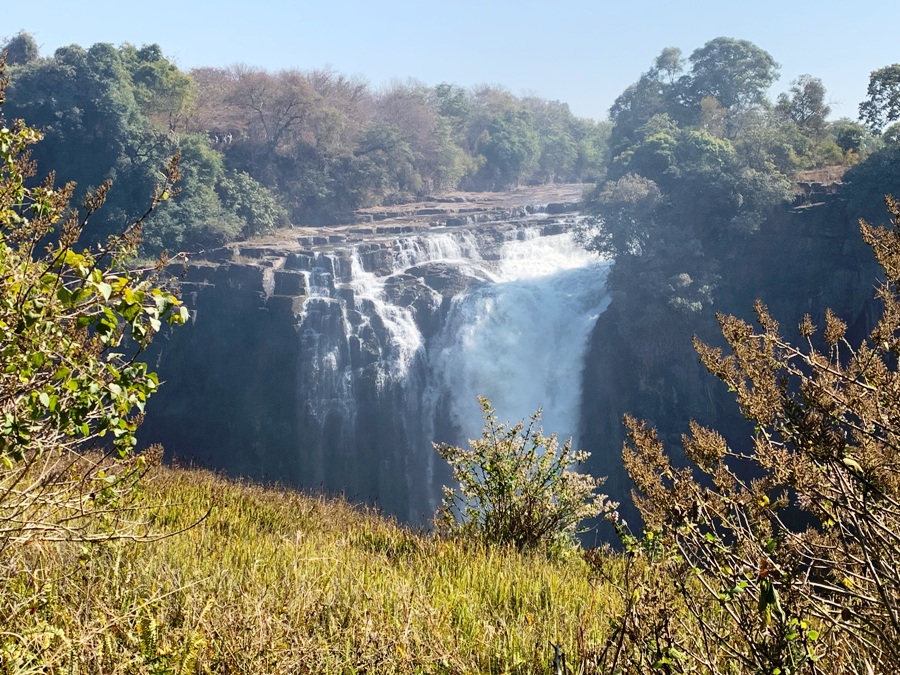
[8,0,900,119]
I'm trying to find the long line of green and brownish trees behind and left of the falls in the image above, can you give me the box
[4,32,610,253]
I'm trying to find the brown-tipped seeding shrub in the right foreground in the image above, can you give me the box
[612,198,900,673]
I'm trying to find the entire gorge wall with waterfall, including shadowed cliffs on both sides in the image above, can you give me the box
[141,186,877,524]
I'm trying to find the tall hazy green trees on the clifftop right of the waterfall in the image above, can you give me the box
[589,37,884,314]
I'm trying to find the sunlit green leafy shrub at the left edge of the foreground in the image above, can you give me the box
[0,63,186,551]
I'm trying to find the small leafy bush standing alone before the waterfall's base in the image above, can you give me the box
[435,396,616,551]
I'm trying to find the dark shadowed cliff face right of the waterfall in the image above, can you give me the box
[581,201,878,522]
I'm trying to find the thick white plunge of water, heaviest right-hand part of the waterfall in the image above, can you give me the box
[430,233,610,448]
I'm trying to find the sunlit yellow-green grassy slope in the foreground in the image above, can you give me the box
[0,468,616,673]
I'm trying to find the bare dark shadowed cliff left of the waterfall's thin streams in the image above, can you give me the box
[141,265,302,480]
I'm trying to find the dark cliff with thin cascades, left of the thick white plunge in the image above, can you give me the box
[140,220,572,524]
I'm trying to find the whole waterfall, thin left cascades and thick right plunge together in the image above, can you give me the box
[288,226,610,523]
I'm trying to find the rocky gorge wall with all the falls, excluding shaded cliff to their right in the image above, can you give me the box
[141,186,608,524]
